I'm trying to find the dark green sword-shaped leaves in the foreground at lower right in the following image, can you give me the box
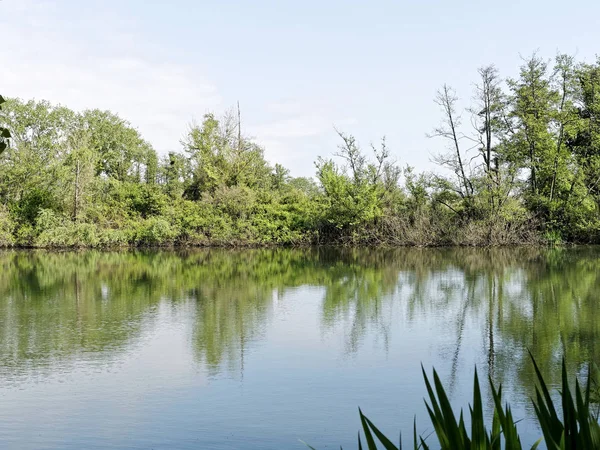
[309,357,600,450]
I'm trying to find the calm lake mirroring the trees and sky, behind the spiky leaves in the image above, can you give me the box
[0,247,600,450]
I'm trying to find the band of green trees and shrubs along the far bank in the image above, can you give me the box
[0,55,600,247]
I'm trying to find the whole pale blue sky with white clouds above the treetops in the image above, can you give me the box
[0,0,600,175]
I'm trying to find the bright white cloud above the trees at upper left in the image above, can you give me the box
[0,0,221,152]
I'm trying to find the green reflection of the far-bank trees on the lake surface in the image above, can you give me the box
[0,248,600,402]
